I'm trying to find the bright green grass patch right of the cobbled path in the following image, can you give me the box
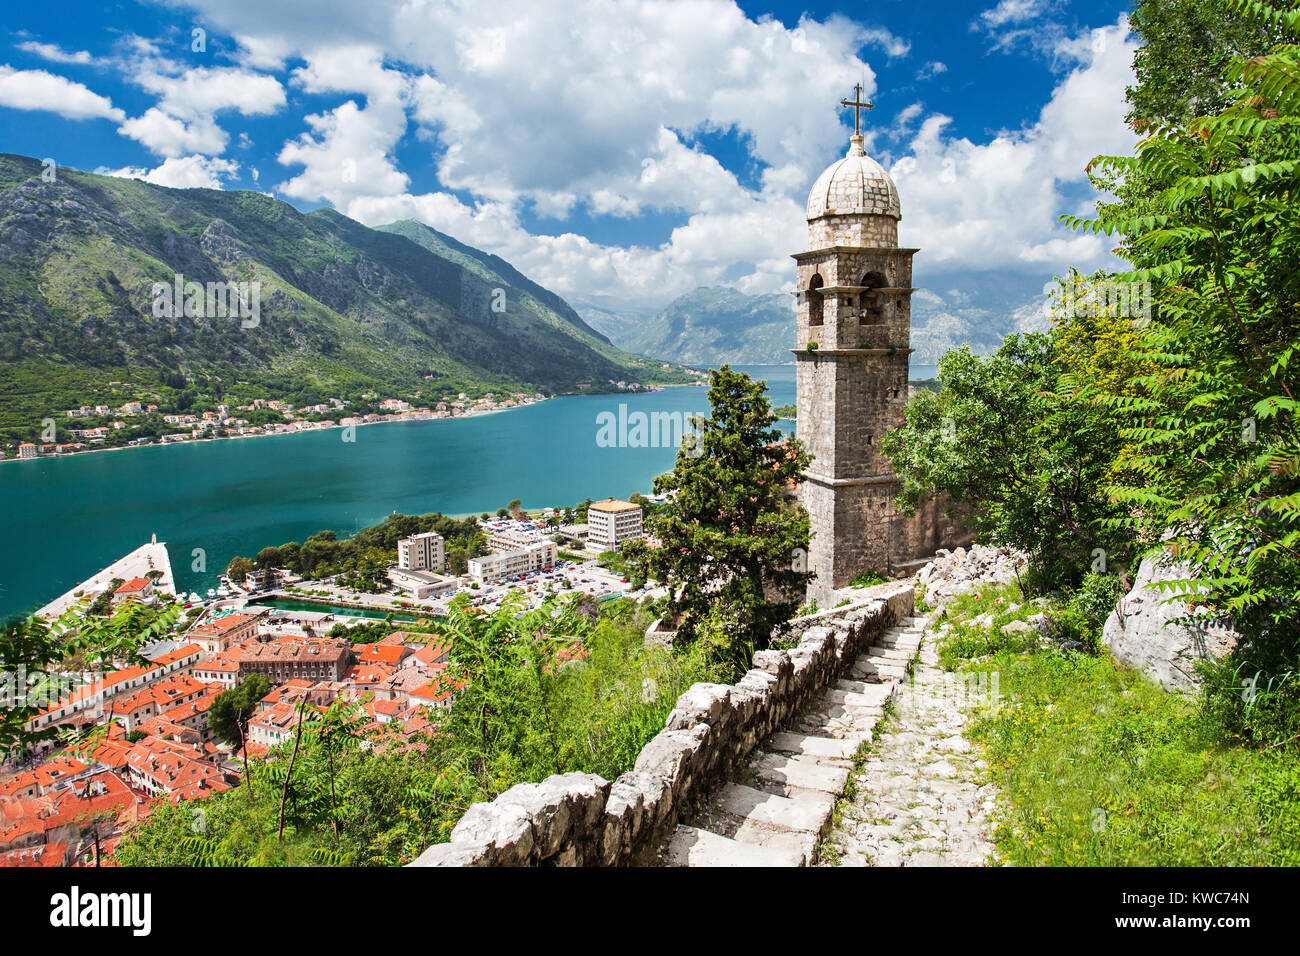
[940,588,1300,866]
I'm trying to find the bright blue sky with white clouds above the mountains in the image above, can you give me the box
[0,0,1134,321]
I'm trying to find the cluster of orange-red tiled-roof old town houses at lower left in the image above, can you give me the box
[0,582,465,866]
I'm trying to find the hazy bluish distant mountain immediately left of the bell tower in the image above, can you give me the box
[618,286,794,365]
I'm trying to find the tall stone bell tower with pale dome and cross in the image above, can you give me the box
[794,87,918,606]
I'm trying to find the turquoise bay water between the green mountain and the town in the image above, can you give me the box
[0,365,794,617]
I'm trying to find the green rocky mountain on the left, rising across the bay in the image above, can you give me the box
[0,153,690,431]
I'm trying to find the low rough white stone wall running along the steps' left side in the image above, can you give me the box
[411,581,914,866]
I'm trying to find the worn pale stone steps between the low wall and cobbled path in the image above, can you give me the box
[659,617,926,866]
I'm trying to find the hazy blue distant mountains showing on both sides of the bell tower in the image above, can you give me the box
[582,273,1041,365]
